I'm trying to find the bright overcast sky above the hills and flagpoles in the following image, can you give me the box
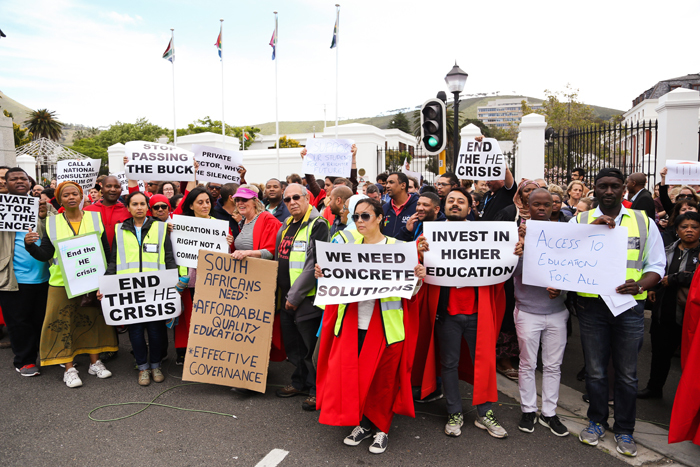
[0,0,700,128]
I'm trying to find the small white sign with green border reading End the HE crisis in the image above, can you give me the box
[55,232,107,298]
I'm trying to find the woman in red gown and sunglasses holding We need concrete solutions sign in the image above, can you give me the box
[316,198,425,454]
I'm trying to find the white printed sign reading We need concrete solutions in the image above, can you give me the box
[314,242,418,306]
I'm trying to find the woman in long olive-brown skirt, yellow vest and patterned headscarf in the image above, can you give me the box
[24,181,118,388]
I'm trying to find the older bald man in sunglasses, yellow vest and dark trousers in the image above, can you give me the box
[275,183,330,411]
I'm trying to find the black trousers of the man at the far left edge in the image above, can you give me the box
[0,282,49,368]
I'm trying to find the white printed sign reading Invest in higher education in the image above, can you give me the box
[423,221,518,287]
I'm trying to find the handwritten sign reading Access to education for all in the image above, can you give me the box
[523,220,628,295]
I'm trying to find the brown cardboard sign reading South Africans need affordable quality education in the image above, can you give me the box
[182,251,277,392]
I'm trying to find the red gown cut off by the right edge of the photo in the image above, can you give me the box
[668,274,700,445]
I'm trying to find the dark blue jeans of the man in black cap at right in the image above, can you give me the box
[578,297,644,435]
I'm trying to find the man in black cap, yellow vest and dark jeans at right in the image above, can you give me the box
[570,168,666,457]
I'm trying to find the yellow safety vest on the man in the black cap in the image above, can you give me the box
[576,209,649,300]
